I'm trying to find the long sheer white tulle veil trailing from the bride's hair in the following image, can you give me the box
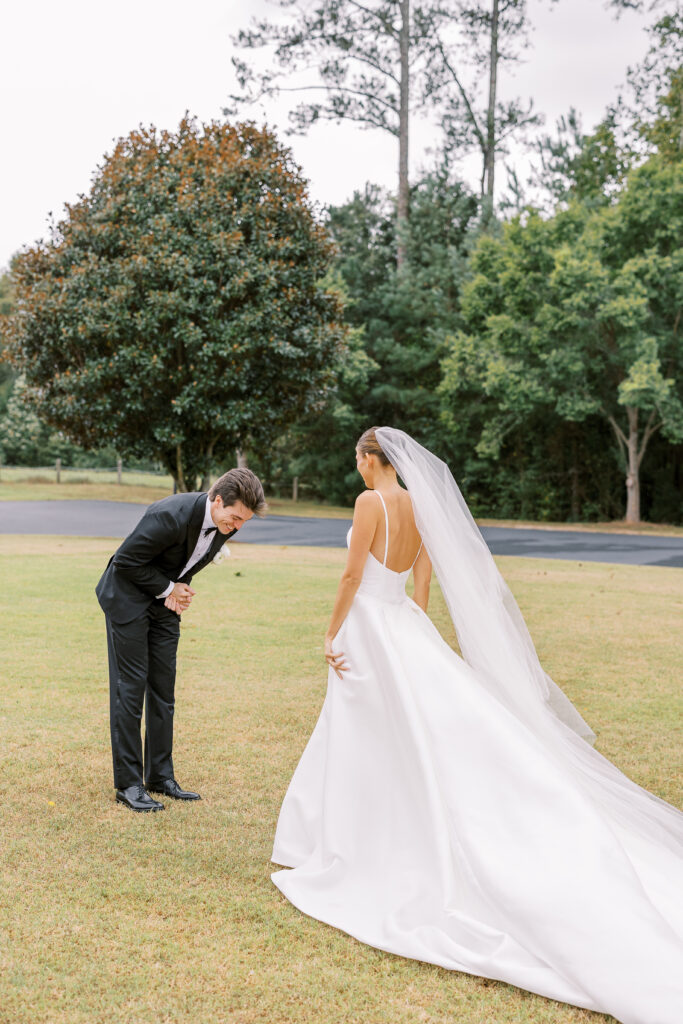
[376,427,683,851]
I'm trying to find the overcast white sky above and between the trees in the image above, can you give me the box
[0,0,647,267]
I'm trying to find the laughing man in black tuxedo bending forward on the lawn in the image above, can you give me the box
[95,469,266,811]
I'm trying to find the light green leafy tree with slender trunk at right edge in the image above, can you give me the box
[440,157,683,521]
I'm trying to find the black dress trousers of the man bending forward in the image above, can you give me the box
[105,601,180,790]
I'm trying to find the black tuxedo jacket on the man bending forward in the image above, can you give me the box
[95,492,236,623]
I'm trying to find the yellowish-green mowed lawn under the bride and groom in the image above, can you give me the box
[0,537,683,1024]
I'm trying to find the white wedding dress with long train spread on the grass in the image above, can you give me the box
[272,493,683,1024]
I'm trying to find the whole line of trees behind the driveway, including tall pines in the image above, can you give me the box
[0,0,683,522]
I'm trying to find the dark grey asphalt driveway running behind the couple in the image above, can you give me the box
[0,501,683,568]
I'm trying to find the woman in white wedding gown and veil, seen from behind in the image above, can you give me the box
[272,427,683,1024]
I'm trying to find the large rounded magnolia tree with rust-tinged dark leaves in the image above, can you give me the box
[3,119,344,490]
